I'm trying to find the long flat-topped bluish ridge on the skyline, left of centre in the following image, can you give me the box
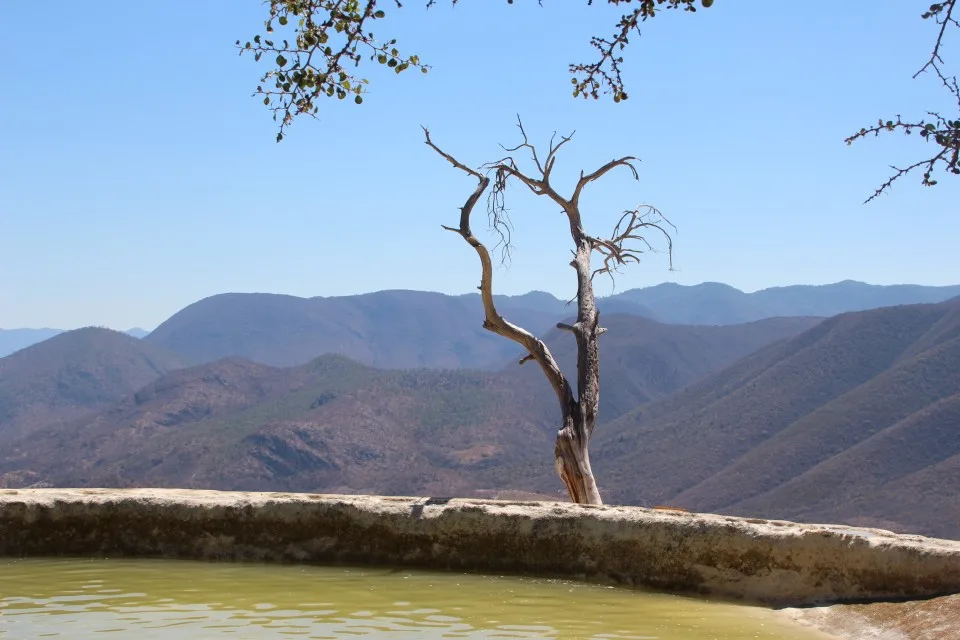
[144,291,567,369]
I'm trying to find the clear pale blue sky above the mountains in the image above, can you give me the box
[0,0,960,328]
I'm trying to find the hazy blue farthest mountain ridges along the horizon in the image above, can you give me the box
[7,280,960,370]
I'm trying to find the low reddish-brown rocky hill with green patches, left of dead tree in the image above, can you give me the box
[0,356,552,495]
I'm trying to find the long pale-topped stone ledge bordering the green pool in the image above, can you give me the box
[0,489,960,607]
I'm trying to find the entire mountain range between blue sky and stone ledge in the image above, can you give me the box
[0,283,960,538]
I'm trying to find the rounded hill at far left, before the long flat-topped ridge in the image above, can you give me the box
[0,327,184,443]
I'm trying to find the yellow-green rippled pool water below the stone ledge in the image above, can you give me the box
[0,558,817,640]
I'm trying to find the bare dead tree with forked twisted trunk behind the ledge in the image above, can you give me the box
[423,118,673,504]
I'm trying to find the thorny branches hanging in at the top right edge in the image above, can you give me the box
[845,0,960,203]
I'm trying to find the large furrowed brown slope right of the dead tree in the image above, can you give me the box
[593,301,960,537]
